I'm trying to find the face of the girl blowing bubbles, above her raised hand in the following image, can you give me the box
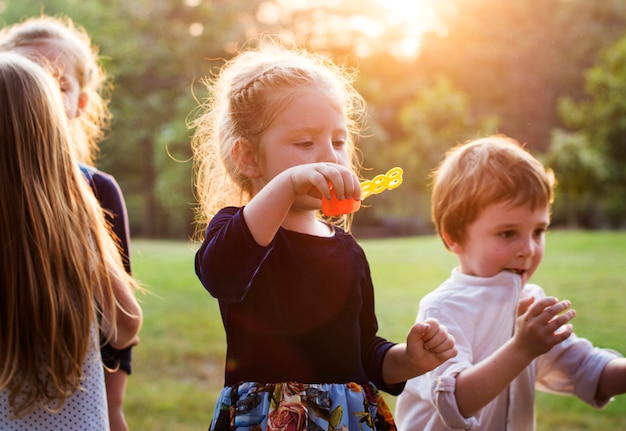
[257,87,350,191]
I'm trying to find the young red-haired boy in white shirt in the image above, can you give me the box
[396,136,626,431]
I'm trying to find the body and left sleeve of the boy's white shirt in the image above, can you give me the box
[396,269,522,431]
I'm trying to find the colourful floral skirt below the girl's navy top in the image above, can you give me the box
[209,382,396,431]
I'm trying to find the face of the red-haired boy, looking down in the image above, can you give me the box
[449,202,550,283]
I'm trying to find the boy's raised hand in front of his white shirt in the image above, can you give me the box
[513,297,576,359]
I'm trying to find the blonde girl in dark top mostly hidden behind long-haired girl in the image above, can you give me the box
[0,15,132,431]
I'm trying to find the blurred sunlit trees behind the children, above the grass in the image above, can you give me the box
[0,0,626,239]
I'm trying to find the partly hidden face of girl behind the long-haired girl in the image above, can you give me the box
[15,42,87,120]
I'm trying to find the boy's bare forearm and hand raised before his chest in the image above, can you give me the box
[455,297,575,417]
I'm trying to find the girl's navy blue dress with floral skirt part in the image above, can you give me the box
[195,207,404,431]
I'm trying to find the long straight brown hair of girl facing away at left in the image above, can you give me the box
[0,53,133,417]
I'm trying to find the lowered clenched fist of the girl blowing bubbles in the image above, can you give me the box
[406,319,458,375]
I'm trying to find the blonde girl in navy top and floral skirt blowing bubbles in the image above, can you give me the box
[193,38,456,430]
